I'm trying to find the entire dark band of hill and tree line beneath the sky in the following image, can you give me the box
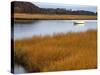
[11,1,97,15]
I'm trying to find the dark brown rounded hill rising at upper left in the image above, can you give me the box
[11,1,39,13]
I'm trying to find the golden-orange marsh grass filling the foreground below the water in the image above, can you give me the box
[14,30,97,72]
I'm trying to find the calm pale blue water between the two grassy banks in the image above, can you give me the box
[14,20,97,39]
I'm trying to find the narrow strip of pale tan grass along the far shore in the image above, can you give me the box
[14,13,97,20]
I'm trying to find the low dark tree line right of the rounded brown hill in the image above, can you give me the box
[39,8,97,15]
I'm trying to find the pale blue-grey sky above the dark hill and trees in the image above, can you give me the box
[32,2,97,12]
